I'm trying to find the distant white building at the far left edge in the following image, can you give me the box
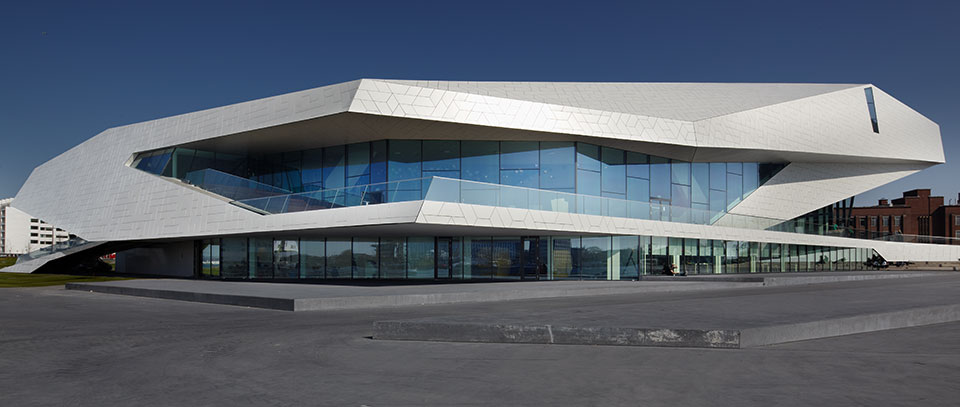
[0,198,70,254]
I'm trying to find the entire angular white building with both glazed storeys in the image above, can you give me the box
[14,79,960,280]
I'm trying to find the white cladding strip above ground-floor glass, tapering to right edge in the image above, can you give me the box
[417,201,960,261]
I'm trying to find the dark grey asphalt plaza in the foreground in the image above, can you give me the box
[0,280,960,407]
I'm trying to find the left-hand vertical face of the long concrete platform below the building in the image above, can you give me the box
[64,283,295,311]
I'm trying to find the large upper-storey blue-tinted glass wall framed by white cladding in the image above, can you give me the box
[131,140,784,223]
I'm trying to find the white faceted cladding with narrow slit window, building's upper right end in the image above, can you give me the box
[695,86,944,163]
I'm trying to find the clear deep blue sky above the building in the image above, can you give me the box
[0,0,960,205]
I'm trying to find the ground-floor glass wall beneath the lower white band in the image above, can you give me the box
[197,236,874,280]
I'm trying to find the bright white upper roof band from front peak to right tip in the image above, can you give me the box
[350,79,943,163]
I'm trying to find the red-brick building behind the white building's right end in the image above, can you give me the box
[850,189,960,244]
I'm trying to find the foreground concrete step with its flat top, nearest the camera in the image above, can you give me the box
[373,273,960,348]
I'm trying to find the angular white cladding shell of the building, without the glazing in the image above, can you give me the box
[14,79,960,278]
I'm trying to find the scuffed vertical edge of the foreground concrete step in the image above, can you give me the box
[373,304,960,348]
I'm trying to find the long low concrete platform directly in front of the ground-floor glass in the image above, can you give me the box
[66,272,945,311]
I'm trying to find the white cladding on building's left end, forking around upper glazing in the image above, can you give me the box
[14,81,359,240]
